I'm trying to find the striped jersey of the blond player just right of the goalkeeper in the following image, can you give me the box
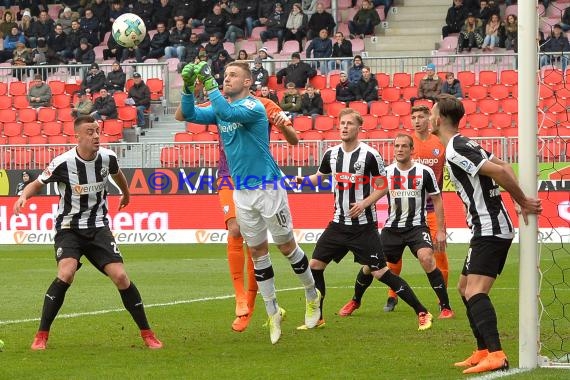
[319,142,386,225]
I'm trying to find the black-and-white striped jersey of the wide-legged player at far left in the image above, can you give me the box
[38,148,119,231]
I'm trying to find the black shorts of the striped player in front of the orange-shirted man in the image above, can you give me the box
[380,226,433,264]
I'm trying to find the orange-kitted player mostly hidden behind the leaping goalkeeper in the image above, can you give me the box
[217,93,299,332]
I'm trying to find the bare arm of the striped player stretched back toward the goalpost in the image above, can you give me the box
[479,157,542,224]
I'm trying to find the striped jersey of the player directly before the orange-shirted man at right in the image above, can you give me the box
[384,163,440,228]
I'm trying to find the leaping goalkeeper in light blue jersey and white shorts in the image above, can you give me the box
[176,61,320,344]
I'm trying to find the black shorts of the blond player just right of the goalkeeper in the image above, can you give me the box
[312,222,386,271]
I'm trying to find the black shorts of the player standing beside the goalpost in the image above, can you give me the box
[461,236,513,278]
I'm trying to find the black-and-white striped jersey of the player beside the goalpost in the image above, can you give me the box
[445,134,514,239]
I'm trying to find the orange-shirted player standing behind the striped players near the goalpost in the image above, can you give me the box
[384,105,453,319]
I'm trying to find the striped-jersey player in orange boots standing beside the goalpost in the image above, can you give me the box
[430,94,542,373]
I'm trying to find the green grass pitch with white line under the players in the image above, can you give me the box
[0,245,567,379]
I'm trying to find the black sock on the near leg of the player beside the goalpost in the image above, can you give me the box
[467,293,501,352]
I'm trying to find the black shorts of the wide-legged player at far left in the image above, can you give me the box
[54,227,123,273]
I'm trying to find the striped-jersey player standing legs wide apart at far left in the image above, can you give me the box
[14,116,162,350]
